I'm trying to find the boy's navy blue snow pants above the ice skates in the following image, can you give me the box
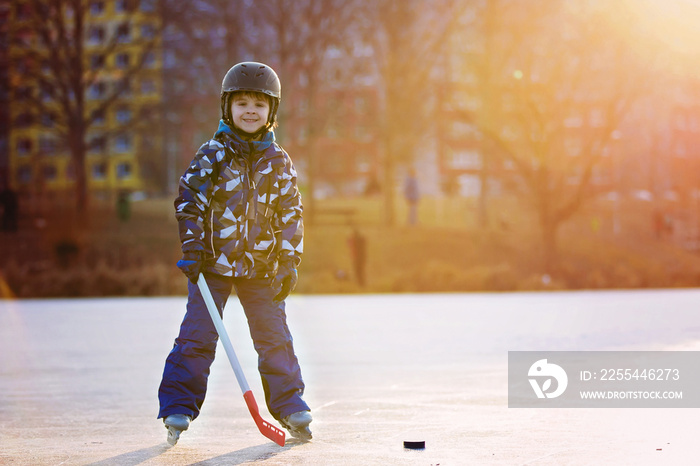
[158,274,309,420]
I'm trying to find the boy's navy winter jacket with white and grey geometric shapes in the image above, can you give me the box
[175,121,304,278]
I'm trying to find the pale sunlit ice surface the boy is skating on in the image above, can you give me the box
[0,290,700,466]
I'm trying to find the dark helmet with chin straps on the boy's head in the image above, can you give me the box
[221,61,282,128]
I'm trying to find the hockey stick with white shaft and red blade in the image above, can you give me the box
[197,273,285,447]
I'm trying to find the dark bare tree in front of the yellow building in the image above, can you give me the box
[13,0,159,212]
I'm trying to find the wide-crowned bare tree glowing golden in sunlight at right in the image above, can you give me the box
[458,0,646,270]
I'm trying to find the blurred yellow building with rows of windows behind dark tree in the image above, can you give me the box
[8,0,162,203]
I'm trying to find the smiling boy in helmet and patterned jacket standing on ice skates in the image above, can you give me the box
[158,62,311,445]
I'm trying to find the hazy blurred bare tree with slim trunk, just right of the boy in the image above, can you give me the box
[368,0,466,225]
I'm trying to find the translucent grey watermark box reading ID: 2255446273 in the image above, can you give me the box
[508,351,700,409]
